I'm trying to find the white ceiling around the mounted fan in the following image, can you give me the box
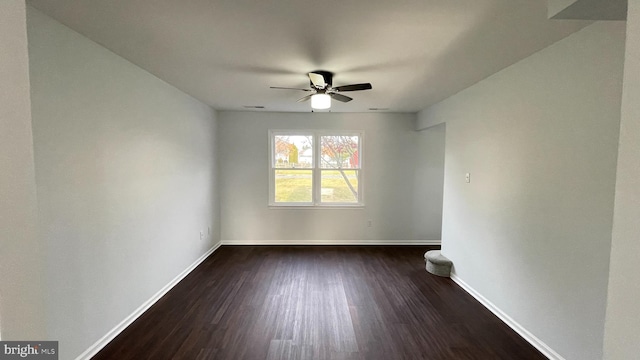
[28,0,590,112]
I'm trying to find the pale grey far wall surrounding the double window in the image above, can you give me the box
[219,112,440,244]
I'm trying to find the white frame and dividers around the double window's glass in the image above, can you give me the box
[267,129,364,209]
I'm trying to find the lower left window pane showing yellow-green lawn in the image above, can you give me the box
[275,169,313,203]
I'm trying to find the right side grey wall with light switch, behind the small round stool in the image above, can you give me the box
[420,22,625,360]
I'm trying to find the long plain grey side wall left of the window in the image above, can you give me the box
[27,8,219,359]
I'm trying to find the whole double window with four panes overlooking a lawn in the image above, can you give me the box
[269,130,362,206]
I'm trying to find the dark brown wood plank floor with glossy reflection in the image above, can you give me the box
[94,246,546,360]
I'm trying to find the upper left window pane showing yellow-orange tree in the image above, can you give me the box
[273,135,313,169]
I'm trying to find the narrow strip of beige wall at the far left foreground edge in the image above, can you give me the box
[0,0,45,340]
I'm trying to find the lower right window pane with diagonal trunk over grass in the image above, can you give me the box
[320,170,358,203]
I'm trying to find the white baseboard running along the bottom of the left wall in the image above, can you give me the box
[76,242,222,360]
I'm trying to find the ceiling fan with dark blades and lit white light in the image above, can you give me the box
[271,71,372,109]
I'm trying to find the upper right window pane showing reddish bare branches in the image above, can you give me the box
[320,135,360,169]
